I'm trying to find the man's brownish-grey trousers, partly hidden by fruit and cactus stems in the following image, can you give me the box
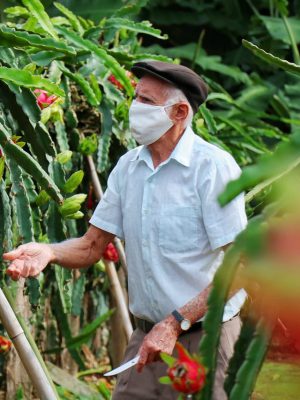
[112,316,241,400]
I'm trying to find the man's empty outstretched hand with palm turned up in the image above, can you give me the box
[3,243,54,281]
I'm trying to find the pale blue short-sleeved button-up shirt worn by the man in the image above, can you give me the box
[90,128,247,323]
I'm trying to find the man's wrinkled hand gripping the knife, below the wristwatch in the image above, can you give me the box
[136,317,181,372]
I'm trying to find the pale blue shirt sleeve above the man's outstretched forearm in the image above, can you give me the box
[89,164,124,238]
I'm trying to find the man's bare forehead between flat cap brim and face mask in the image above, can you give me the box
[136,75,171,101]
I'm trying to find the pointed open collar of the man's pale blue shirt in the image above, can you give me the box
[131,126,195,167]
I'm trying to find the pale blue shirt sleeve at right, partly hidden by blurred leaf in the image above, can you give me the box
[200,153,247,250]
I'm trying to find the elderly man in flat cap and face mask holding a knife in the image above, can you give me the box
[4,61,246,400]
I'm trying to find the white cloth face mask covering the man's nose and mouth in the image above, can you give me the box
[129,100,174,146]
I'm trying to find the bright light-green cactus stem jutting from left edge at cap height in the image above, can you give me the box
[0,67,65,97]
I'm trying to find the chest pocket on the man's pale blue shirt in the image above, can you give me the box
[158,206,200,253]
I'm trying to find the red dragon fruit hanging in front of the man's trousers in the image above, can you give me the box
[167,342,205,394]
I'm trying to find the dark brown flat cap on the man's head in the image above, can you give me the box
[131,61,208,113]
